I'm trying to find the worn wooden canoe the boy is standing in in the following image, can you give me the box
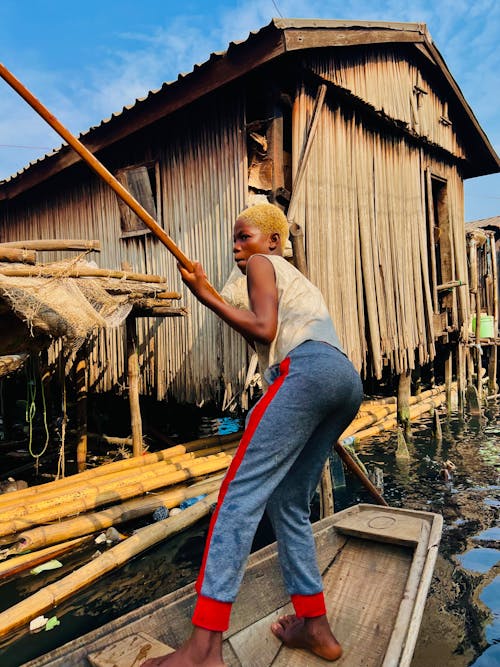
[20,504,442,667]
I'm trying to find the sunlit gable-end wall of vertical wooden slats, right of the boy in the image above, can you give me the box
[293,51,468,378]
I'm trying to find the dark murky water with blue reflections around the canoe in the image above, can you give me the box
[0,402,500,667]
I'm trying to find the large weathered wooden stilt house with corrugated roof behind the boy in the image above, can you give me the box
[0,19,500,401]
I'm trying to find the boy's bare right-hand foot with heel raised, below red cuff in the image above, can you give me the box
[271,615,342,661]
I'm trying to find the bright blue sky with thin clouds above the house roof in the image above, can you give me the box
[0,0,500,220]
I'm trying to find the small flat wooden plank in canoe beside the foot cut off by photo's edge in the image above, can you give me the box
[87,632,174,667]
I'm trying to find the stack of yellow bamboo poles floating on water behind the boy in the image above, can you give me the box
[0,386,445,636]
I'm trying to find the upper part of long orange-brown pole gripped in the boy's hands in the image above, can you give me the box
[0,63,222,301]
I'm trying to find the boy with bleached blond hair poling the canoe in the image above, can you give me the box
[143,204,362,667]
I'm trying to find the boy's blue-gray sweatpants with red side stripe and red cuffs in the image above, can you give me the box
[193,341,363,631]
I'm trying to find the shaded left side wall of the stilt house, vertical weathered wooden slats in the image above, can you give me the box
[0,92,247,402]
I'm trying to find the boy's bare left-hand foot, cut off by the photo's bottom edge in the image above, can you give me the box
[141,627,226,667]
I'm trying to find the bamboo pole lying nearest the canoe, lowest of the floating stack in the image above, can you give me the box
[0,493,217,637]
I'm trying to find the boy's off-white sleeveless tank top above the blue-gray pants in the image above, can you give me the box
[222,255,342,375]
